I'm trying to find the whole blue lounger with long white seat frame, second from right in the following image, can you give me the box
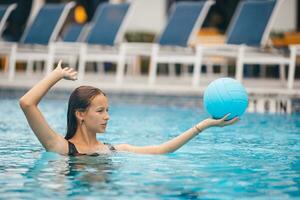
[118,1,214,84]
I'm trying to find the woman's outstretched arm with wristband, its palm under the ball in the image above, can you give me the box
[115,115,238,154]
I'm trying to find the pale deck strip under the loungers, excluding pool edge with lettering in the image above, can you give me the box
[0,73,300,99]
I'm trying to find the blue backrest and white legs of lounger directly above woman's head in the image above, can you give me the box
[78,3,130,80]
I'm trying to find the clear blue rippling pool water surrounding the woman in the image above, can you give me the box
[0,98,300,200]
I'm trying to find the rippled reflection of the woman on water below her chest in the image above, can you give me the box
[24,152,117,194]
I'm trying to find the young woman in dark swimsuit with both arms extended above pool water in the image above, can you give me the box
[20,61,238,155]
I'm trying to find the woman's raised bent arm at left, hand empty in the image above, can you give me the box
[19,62,76,154]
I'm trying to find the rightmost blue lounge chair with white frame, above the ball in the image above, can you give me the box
[196,0,291,88]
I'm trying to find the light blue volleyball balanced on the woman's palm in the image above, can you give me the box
[203,78,248,120]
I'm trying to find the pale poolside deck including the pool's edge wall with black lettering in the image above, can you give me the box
[0,73,300,114]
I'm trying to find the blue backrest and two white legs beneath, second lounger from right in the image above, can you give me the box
[149,1,214,85]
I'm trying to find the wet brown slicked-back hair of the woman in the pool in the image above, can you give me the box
[65,86,106,140]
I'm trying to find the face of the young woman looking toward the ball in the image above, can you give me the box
[83,94,109,133]
